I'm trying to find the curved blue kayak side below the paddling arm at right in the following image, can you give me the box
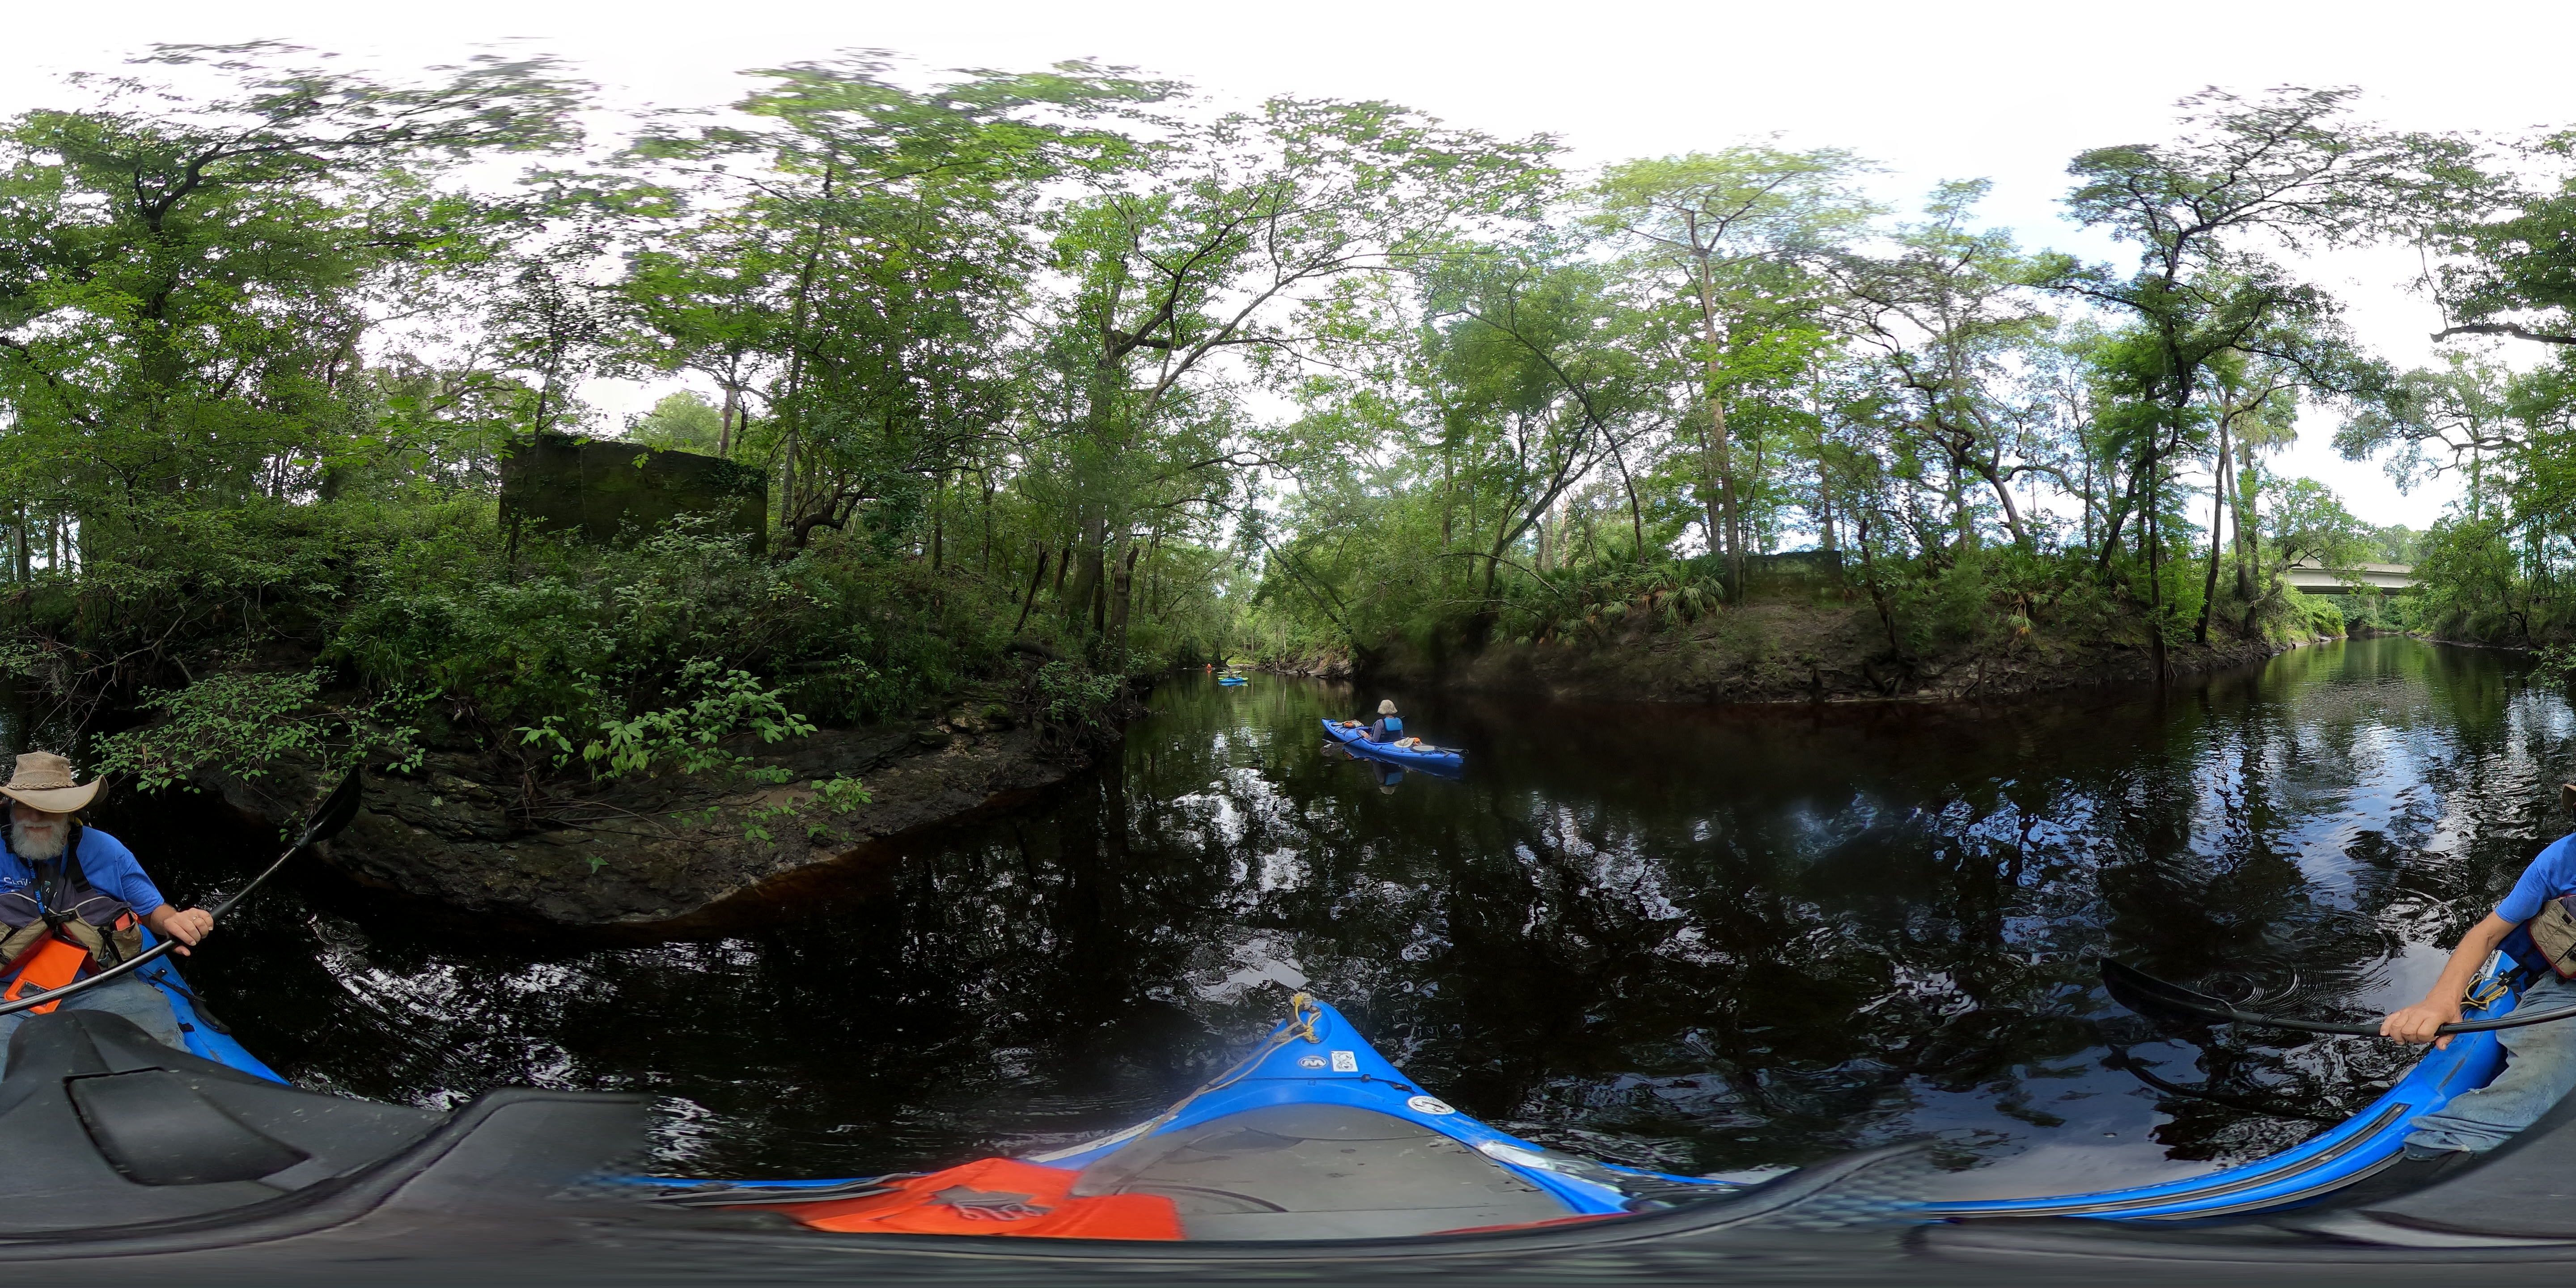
[1919,958,2514,1221]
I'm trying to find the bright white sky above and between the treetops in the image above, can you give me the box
[0,0,2576,528]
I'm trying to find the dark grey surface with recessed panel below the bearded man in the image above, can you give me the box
[0,1010,448,1237]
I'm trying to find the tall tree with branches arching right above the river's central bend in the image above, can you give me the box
[1041,98,1553,654]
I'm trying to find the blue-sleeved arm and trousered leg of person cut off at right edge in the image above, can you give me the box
[2380,835,2576,1162]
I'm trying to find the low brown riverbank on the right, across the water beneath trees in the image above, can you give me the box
[1368,603,2336,703]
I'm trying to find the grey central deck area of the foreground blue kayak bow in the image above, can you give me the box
[1072,1105,1572,1239]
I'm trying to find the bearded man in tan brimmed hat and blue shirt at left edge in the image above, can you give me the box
[0,752,214,1072]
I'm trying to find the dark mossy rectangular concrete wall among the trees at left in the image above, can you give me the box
[500,433,770,543]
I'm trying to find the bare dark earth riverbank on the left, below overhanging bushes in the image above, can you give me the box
[199,703,1115,932]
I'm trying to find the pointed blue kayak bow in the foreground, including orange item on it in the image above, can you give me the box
[636,994,1746,1241]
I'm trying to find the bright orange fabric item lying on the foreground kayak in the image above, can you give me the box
[745,1159,1180,1239]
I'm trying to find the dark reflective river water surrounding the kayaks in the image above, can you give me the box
[30,639,2576,1193]
